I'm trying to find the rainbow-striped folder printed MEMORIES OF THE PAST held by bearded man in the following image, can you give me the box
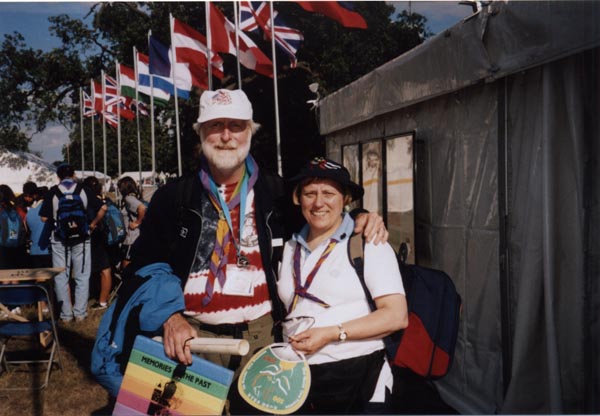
[113,335,233,416]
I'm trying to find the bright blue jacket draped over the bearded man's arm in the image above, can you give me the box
[91,263,185,397]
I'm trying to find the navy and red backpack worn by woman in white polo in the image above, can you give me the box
[348,234,461,379]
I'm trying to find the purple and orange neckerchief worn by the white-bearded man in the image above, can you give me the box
[199,155,258,306]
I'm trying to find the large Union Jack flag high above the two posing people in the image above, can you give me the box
[240,1,304,68]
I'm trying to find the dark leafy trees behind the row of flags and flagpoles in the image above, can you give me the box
[0,2,430,175]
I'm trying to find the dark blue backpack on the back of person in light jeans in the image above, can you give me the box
[54,184,90,246]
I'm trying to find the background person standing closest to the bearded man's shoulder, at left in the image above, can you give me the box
[117,176,146,270]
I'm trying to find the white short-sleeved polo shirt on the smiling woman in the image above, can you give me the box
[278,214,404,401]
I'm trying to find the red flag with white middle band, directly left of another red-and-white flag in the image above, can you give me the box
[171,17,223,89]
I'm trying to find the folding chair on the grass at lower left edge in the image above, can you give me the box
[0,282,62,390]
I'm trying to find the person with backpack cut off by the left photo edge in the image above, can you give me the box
[0,184,28,269]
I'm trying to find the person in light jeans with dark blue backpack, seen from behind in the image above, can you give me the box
[40,163,105,322]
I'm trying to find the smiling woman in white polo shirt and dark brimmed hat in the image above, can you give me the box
[278,158,408,414]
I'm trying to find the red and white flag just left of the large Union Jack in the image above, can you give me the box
[210,3,273,78]
